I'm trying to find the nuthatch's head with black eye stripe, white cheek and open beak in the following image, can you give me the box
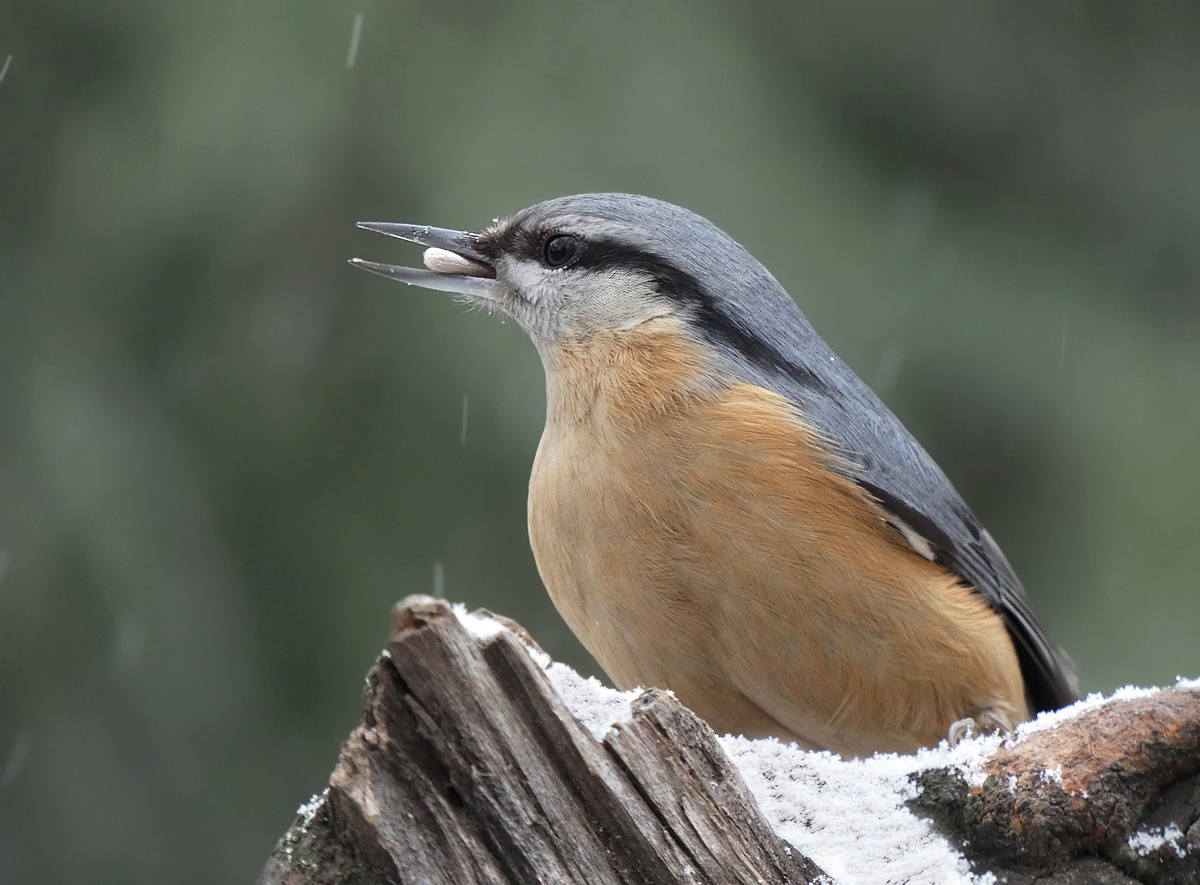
[352,194,806,371]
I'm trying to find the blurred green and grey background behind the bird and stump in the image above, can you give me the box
[0,0,1200,883]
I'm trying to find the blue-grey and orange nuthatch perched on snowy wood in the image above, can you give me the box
[350,193,1079,757]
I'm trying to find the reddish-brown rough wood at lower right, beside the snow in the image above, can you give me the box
[914,688,1200,885]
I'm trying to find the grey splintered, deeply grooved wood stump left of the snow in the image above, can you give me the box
[259,597,821,885]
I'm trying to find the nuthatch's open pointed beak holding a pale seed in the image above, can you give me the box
[350,222,496,299]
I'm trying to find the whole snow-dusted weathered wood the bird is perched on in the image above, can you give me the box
[259,597,1200,885]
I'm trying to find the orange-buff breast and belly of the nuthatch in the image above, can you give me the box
[529,318,1027,754]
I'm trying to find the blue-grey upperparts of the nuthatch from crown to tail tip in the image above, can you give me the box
[501,194,1079,711]
